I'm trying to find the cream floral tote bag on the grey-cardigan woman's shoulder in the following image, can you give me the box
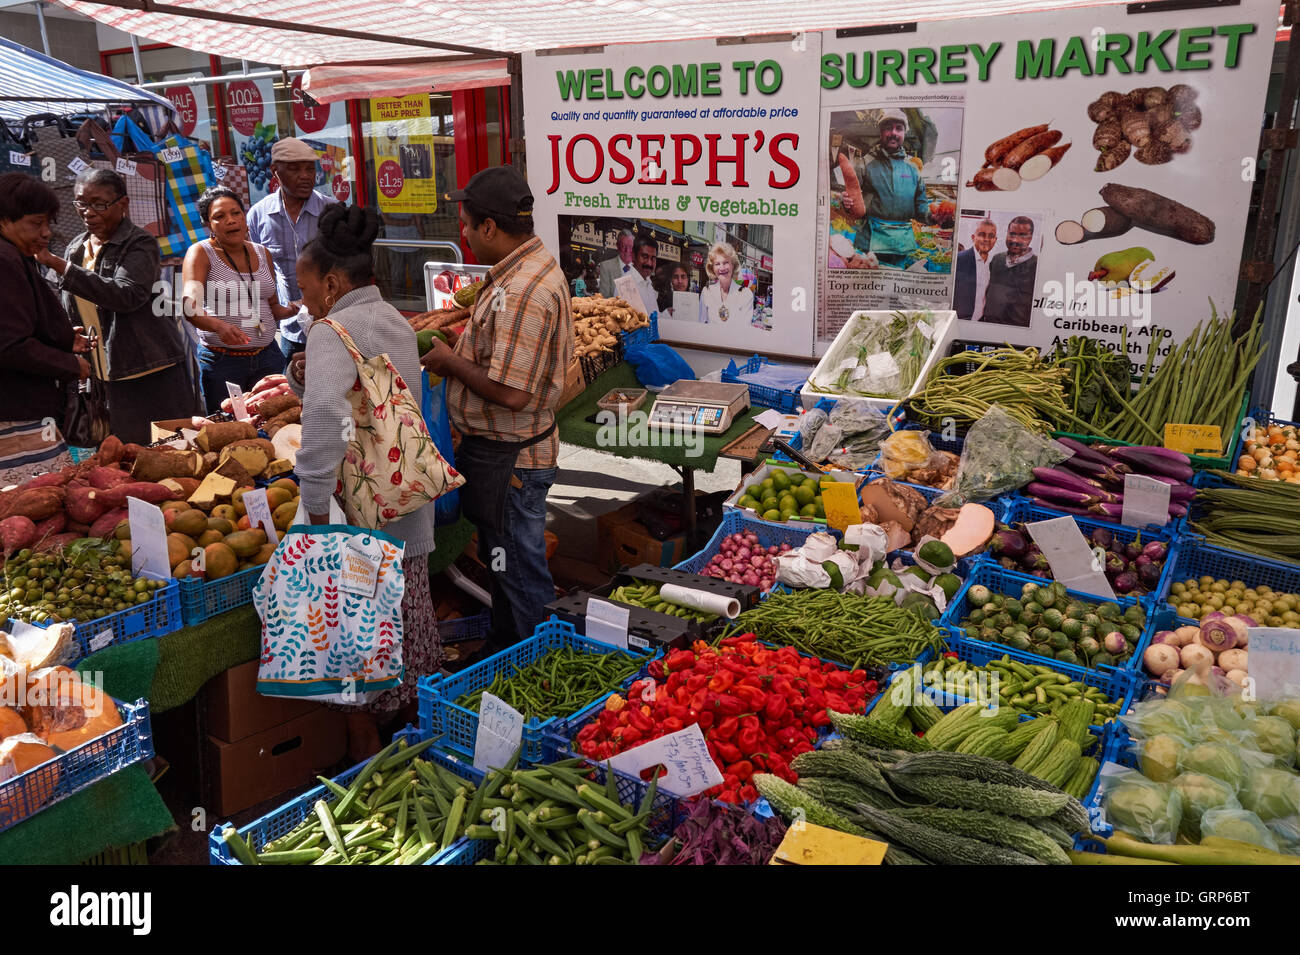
[308,318,465,528]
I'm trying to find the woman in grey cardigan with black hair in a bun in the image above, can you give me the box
[289,204,442,761]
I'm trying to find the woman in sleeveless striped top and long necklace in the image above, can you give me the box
[182,186,298,414]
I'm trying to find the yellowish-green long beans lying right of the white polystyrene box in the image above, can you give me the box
[907,347,1084,431]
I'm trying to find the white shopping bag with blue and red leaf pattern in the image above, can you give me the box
[252,504,406,704]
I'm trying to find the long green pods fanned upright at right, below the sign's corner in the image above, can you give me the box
[1092,303,1264,454]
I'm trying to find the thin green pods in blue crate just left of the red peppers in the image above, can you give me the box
[456,647,646,720]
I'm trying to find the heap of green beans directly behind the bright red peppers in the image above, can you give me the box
[736,590,944,669]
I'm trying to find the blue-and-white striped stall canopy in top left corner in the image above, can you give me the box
[0,36,176,121]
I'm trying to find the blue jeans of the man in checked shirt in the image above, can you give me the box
[478,468,556,655]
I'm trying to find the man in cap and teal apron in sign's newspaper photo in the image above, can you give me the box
[841,109,930,269]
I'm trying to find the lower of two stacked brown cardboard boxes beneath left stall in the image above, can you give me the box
[204,706,347,816]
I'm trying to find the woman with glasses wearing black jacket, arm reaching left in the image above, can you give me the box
[36,169,198,444]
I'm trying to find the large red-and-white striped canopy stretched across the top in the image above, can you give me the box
[57,0,1289,69]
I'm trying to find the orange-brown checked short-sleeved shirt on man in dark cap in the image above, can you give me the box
[447,236,573,468]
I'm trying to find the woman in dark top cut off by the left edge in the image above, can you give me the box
[0,173,90,487]
